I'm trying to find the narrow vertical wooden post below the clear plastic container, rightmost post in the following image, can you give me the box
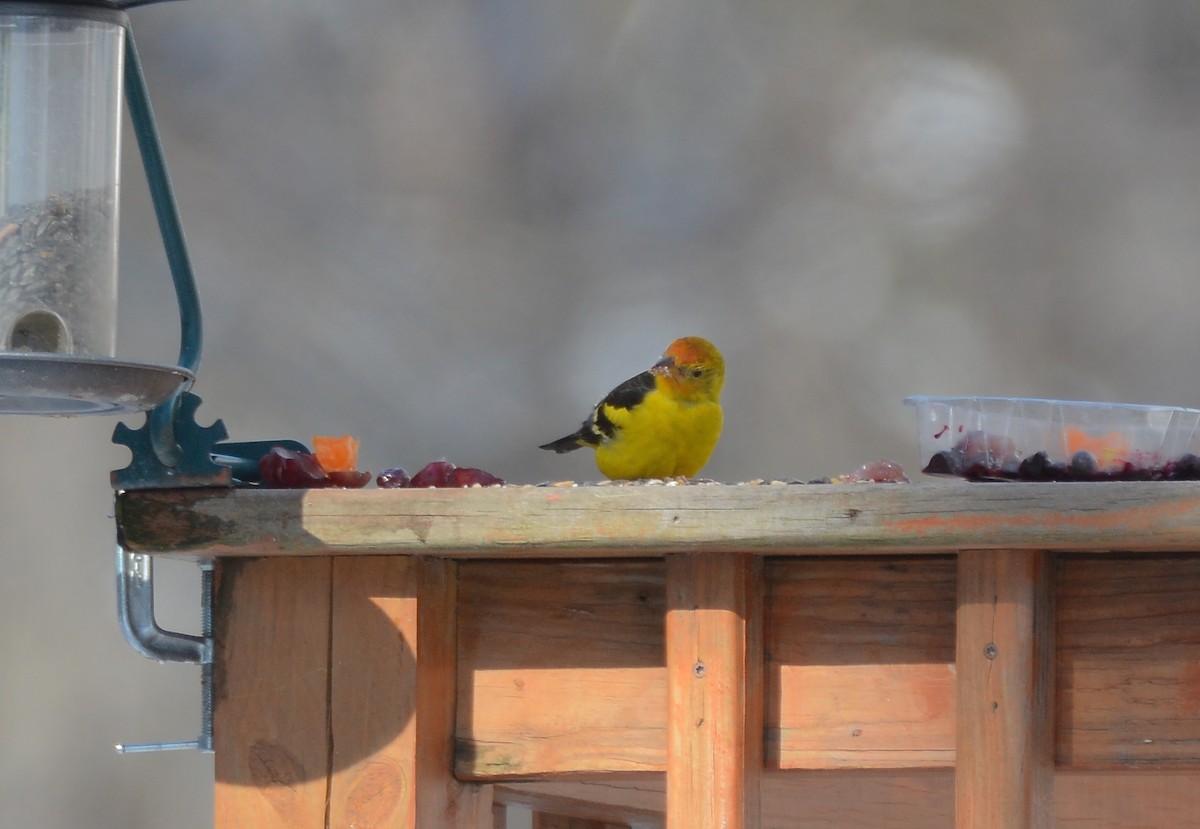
[955,549,1055,829]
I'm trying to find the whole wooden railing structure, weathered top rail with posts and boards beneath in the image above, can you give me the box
[116,482,1200,829]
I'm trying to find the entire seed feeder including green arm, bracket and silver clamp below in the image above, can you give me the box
[0,0,265,751]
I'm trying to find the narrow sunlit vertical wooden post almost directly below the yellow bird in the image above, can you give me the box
[666,553,764,829]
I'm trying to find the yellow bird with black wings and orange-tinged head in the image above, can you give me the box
[540,337,725,480]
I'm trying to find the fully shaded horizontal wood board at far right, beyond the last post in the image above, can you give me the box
[1057,555,1200,769]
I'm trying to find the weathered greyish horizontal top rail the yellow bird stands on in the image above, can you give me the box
[116,482,1200,559]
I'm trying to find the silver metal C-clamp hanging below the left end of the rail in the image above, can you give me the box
[114,546,212,755]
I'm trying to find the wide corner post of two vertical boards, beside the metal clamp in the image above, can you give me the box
[214,557,493,829]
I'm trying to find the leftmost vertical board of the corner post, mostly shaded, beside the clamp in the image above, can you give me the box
[214,558,332,829]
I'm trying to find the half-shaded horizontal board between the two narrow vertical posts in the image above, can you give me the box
[766,557,955,769]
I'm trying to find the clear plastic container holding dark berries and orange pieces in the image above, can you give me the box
[905,397,1200,481]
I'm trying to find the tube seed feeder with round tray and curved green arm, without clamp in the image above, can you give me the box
[0,0,199,415]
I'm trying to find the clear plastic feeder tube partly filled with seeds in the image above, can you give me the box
[0,2,125,356]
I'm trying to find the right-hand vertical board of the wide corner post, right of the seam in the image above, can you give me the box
[329,555,493,829]
